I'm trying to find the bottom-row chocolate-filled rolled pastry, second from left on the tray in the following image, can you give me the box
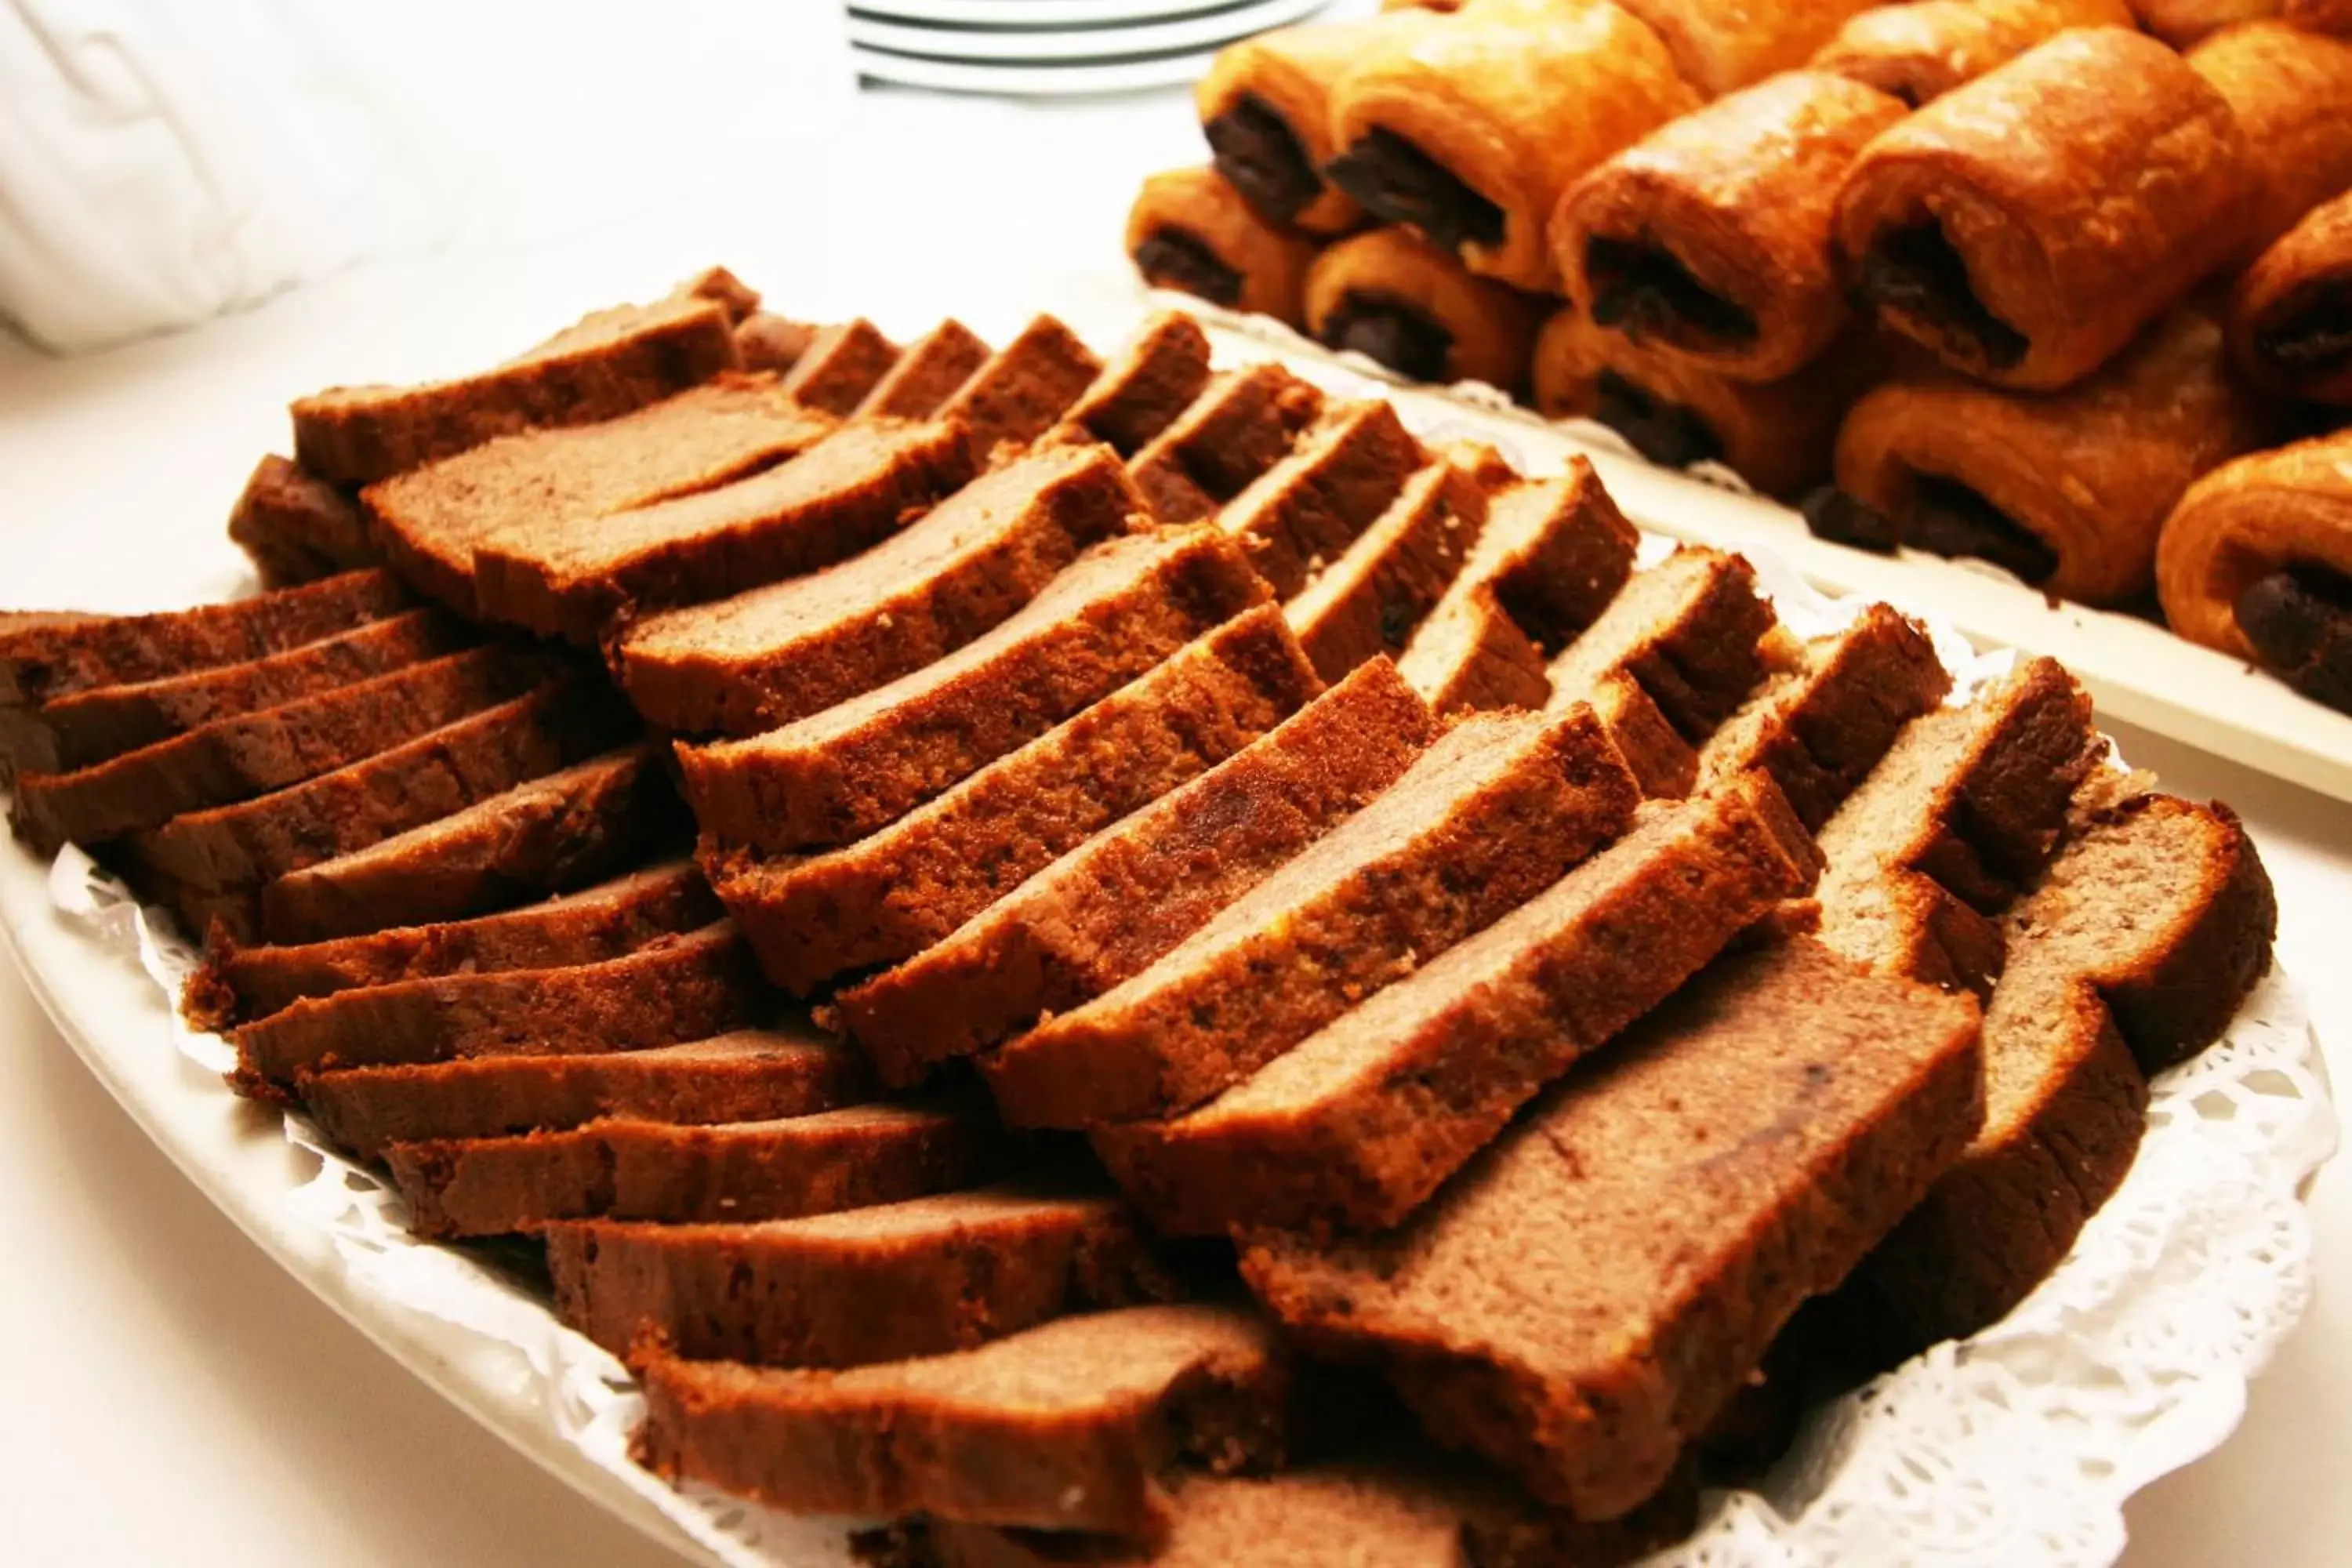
[1305,228,1536,395]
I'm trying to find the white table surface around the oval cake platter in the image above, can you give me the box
[0,76,2352,1568]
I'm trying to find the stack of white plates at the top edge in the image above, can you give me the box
[851,0,1329,96]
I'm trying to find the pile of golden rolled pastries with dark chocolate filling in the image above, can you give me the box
[1129,0,2352,710]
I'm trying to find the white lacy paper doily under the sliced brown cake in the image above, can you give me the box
[23,376,2338,1568]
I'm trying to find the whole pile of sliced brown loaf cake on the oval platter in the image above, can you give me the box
[0,276,2274,1568]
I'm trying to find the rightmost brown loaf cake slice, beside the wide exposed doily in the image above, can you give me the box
[1842,794,2277,1356]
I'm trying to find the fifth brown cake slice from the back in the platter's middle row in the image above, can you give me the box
[677,529,1265,848]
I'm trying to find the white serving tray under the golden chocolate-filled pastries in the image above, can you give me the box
[1185,305,2352,801]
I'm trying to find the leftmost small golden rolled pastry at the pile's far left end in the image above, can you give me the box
[1127,169,1315,327]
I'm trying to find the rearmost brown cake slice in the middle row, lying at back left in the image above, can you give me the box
[294,294,741,485]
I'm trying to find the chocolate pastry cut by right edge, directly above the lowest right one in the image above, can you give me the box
[2230,193,2352,405]
